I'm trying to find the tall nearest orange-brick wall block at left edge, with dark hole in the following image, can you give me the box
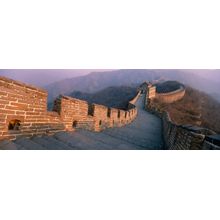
[0,77,64,139]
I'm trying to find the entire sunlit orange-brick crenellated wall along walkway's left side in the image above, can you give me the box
[0,77,140,140]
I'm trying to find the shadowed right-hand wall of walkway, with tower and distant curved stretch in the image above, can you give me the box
[145,85,220,150]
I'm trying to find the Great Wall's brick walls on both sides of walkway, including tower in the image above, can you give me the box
[0,77,220,150]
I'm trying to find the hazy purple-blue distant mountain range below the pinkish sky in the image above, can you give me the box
[45,69,220,101]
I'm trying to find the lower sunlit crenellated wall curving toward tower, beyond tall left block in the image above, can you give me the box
[53,92,140,131]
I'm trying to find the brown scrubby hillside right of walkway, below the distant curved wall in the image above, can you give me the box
[151,87,220,133]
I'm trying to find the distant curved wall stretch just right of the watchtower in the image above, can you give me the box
[155,86,185,103]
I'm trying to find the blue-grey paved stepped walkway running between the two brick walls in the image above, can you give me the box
[0,96,163,150]
